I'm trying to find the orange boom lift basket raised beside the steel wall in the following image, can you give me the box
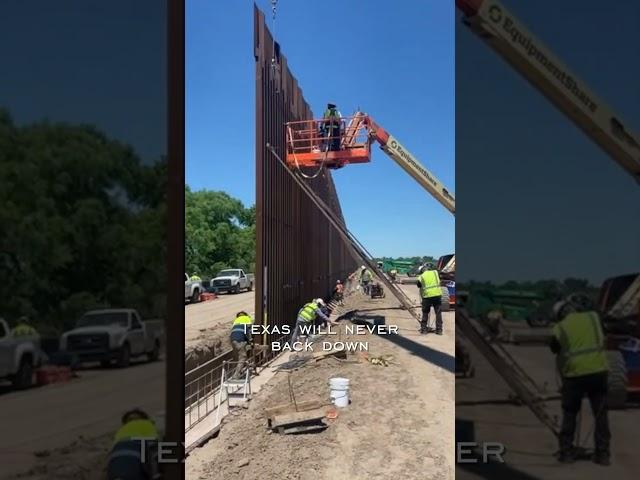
[285,113,372,169]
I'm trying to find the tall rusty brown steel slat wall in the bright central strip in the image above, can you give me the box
[254,5,356,343]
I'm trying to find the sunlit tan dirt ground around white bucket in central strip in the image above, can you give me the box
[187,285,455,480]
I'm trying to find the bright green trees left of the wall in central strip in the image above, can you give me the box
[185,185,256,279]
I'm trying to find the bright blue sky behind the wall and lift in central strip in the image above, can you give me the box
[185,0,455,256]
